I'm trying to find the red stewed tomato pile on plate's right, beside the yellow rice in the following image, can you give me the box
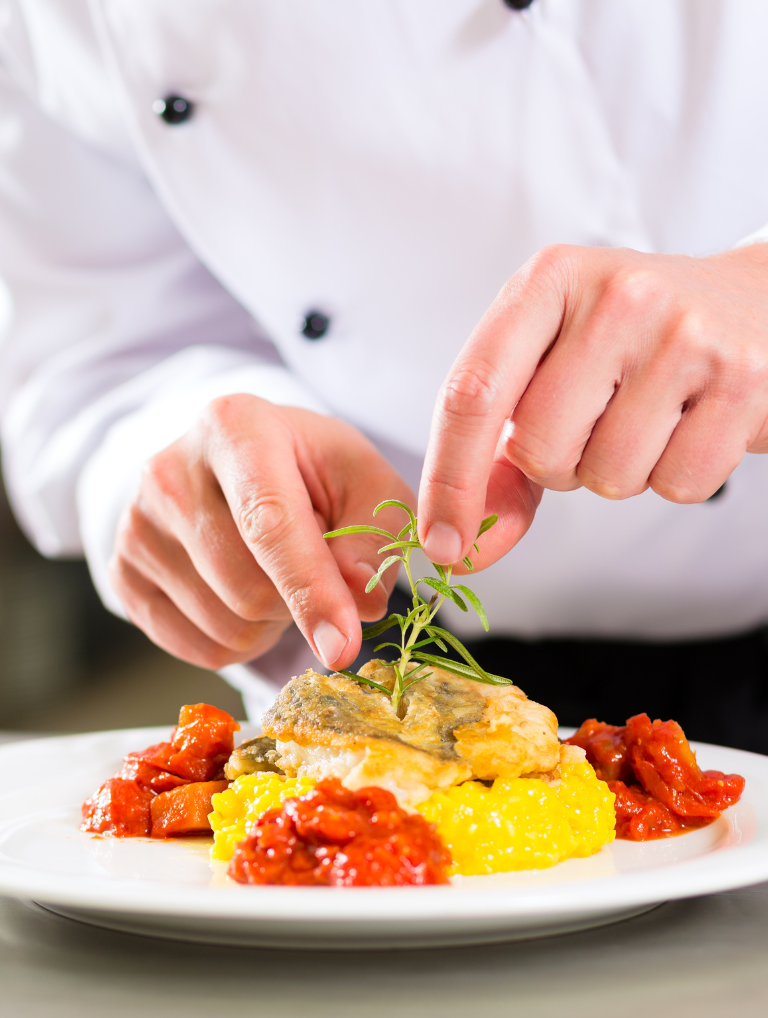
[566,714,745,841]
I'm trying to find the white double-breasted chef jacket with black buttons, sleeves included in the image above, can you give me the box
[0,0,768,712]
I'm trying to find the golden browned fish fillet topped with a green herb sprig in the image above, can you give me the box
[258,662,559,808]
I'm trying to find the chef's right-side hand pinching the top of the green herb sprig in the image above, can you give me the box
[419,244,768,566]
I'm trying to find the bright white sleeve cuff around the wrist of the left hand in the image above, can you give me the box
[77,347,330,618]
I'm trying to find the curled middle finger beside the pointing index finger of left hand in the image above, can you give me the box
[141,441,287,622]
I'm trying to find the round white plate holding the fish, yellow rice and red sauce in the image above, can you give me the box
[0,728,768,948]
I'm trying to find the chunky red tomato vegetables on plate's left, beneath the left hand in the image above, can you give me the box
[80,703,240,838]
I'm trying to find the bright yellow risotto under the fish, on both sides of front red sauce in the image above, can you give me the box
[210,761,615,876]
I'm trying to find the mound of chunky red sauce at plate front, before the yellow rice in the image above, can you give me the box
[229,779,451,887]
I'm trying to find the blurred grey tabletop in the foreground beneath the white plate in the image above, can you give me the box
[0,736,768,1018]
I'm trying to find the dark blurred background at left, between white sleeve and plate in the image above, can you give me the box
[0,460,245,733]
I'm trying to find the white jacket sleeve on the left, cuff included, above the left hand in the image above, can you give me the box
[0,67,324,611]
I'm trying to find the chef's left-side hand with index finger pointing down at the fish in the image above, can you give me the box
[110,395,414,668]
